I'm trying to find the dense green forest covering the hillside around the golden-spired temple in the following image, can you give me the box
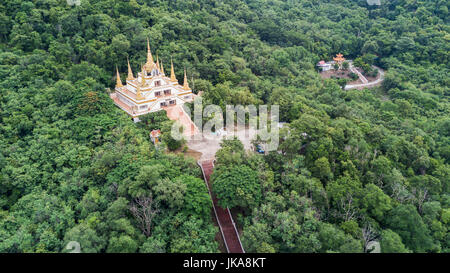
[0,0,450,252]
